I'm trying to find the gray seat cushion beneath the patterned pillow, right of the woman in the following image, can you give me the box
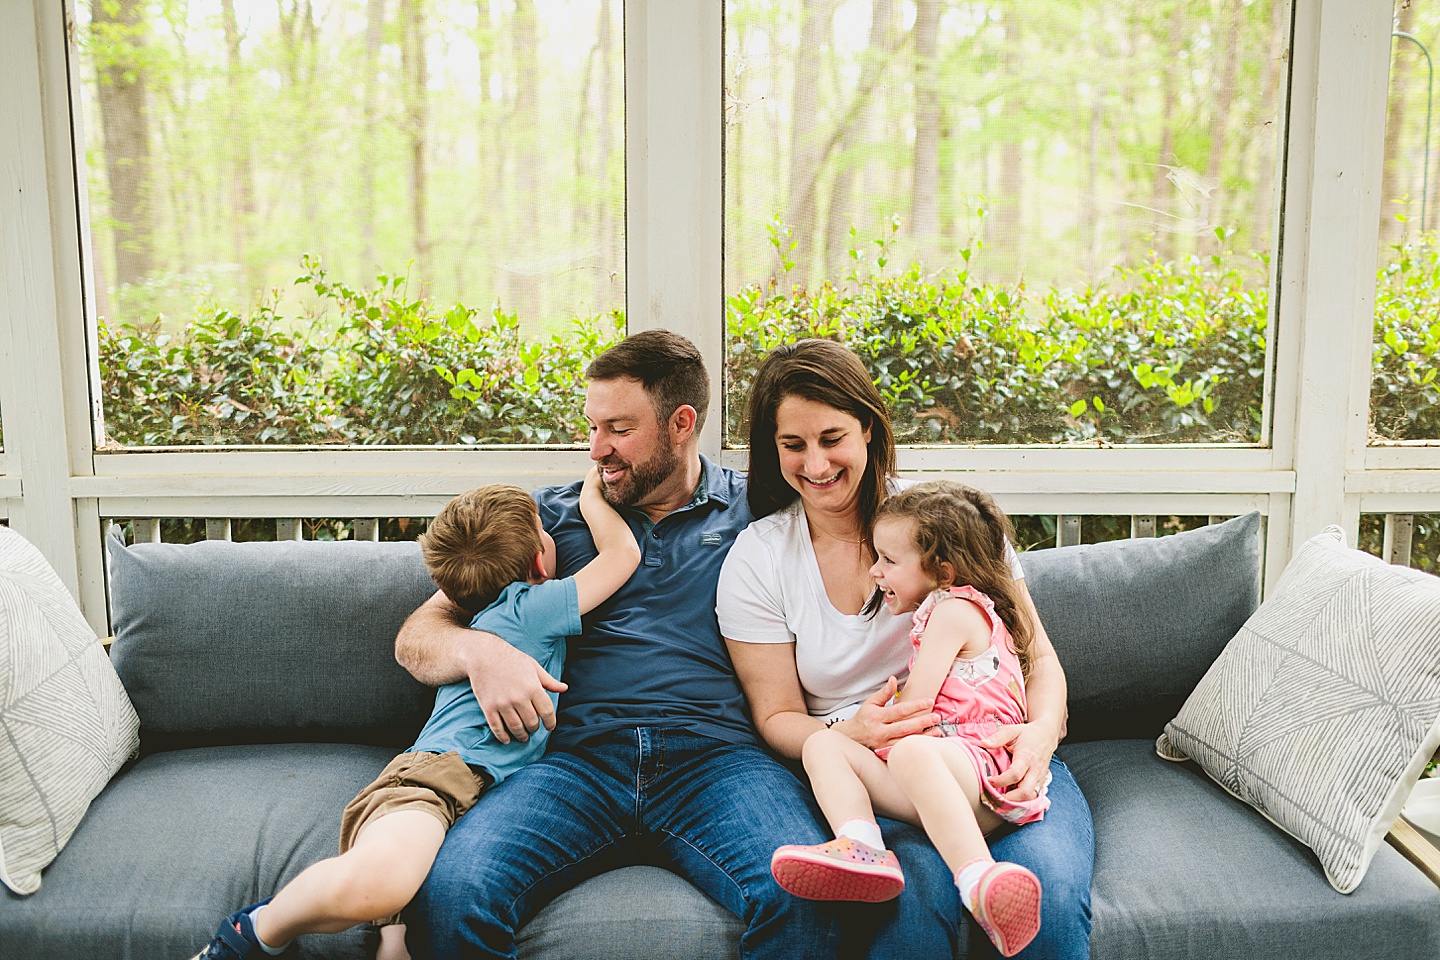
[1060,740,1440,960]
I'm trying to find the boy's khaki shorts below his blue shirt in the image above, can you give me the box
[340,750,490,853]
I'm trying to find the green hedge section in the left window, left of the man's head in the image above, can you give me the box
[99,258,624,446]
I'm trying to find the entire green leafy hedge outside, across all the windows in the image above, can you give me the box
[5,237,1440,446]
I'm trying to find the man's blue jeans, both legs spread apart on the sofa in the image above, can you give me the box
[409,727,841,960]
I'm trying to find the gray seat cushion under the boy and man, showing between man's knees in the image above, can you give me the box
[0,744,744,960]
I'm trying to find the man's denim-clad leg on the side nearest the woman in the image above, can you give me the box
[641,730,848,960]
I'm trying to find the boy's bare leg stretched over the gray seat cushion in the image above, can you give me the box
[255,810,445,947]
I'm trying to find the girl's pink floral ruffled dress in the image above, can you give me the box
[875,586,1050,823]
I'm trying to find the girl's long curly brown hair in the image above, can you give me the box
[876,481,1034,678]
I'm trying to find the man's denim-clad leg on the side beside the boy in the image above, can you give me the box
[406,741,634,960]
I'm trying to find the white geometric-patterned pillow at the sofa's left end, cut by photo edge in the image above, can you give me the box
[0,527,140,894]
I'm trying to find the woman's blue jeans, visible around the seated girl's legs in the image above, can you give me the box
[847,759,1094,960]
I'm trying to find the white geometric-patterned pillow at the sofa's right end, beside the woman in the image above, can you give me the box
[1155,527,1440,894]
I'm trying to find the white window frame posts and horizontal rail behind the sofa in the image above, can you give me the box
[0,0,1440,630]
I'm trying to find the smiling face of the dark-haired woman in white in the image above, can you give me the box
[775,397,870,512]
